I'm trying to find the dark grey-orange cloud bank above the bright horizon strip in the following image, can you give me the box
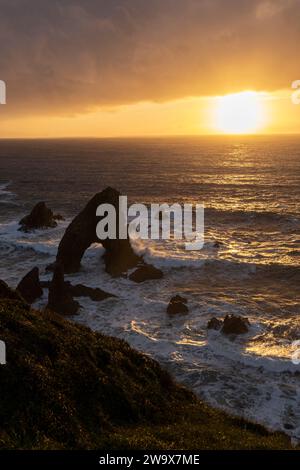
[0,0,300,114]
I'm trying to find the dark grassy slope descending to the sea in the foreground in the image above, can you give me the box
[0,300,290,449]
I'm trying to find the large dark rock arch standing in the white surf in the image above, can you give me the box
[56,187,142,276]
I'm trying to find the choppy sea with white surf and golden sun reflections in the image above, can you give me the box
[0,137,300,441]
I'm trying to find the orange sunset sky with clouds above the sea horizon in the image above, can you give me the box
[0,0,300,137]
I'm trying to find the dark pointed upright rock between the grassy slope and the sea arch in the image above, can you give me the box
[47,263,80,315]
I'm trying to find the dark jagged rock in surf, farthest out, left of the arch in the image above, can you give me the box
[19,202,61,232]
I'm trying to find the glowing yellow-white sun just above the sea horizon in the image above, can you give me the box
[215,91,265,134]
